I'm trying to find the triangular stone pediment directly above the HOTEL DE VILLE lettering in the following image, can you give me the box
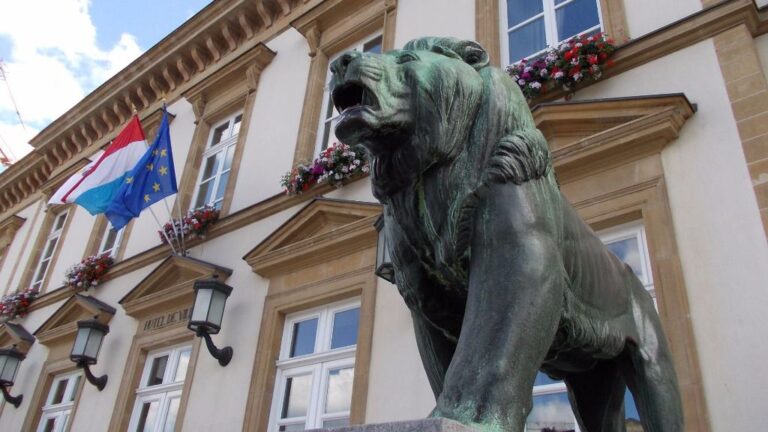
[119,255,232,317]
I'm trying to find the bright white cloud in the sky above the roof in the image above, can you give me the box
[0,0,142,162]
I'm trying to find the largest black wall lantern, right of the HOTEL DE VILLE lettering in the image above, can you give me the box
[187,275,232,366]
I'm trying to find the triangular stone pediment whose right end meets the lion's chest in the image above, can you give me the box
[243,198,381,277]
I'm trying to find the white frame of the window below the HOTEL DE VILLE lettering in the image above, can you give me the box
[128,344,192,431]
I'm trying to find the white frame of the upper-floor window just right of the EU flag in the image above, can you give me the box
[190,111,245,210]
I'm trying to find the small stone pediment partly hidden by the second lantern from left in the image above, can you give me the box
[35,294,115,345]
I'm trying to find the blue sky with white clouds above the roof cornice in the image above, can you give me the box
[0,0,211,171]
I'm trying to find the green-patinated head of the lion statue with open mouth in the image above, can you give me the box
[331,37,535,202]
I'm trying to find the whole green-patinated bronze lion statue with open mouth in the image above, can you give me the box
[331,37,683,432]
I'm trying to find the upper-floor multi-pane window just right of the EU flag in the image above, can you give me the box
[192,112,243,209]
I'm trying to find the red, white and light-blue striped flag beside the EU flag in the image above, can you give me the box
[49,116,147,215]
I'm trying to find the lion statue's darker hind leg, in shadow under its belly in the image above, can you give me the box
[565,360,627,432]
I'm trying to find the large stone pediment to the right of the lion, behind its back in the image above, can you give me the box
[532,94,696,181]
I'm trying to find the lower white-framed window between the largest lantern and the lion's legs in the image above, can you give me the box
[270,300,360,432]
